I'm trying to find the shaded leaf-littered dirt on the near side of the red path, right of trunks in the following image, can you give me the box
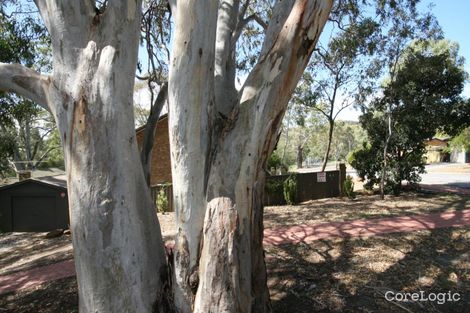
[266,211,470,313]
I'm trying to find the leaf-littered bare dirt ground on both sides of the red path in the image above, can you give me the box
[0,193,470,313]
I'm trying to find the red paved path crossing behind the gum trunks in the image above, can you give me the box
[0,209,470,294]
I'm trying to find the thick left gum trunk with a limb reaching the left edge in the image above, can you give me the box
[0,0,168,313]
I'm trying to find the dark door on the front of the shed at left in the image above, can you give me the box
[11,196,56,232]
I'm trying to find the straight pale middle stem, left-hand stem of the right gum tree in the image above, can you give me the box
[168,0,218,312]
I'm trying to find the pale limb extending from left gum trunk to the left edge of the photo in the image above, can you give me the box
[0,63,51,112]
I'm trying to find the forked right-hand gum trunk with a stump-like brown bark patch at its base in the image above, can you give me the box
[169,1,332,312]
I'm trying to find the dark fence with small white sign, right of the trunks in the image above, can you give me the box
[264,164,346,205]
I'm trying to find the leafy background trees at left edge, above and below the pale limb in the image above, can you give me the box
[0,1,60,173]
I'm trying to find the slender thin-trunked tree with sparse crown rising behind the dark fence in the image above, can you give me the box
[294,18,379,171]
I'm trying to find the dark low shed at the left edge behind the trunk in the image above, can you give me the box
[0,176,69,232]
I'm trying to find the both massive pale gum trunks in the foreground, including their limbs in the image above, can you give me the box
[0,0,332,312]
